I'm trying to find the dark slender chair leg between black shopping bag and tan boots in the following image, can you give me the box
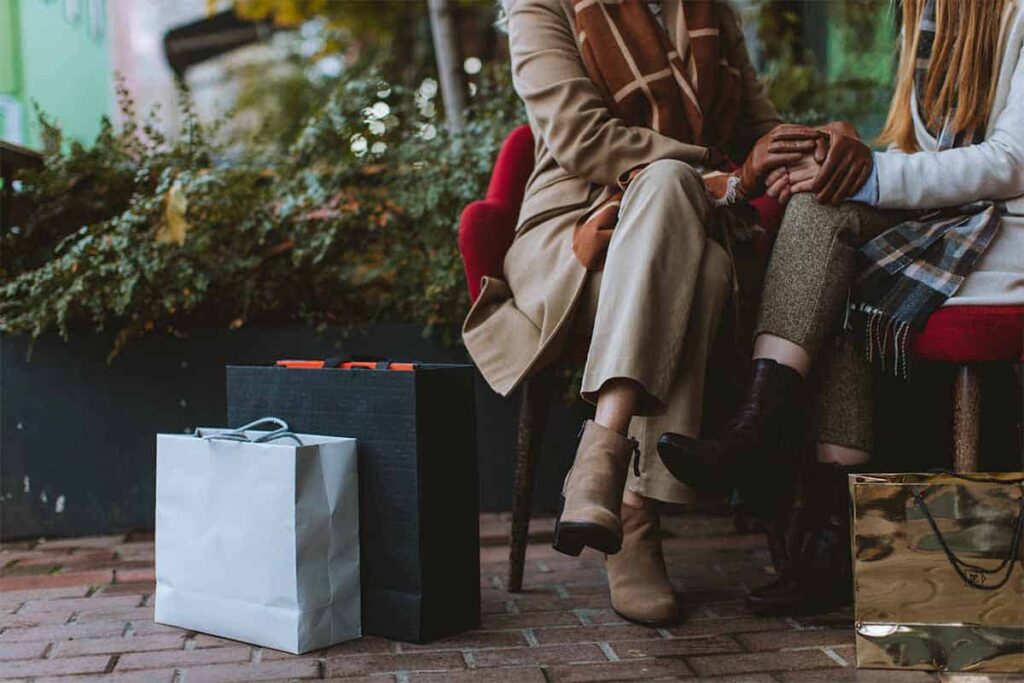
[508,371,552,593]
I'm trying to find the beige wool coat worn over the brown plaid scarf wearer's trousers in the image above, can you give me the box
[463,0,779,395]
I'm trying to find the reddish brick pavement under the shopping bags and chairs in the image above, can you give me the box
[0,514,1011,683]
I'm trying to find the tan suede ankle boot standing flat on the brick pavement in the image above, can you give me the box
[605,499,680,626]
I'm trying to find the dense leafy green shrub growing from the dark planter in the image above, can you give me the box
[0,67,522,360]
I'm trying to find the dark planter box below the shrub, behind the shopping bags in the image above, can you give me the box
[0,325,586,541]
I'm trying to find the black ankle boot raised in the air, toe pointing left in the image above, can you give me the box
[657,358,804,515]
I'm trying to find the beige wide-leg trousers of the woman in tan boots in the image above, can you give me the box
[574,160,732,503]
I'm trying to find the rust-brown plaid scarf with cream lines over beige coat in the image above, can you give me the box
[572,0,740,270]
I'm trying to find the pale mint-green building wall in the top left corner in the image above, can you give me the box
[0,0,114,147]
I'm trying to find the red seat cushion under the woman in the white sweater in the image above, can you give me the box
[912,306,1024,364]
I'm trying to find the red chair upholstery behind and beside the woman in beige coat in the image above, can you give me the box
[459,126,782,301]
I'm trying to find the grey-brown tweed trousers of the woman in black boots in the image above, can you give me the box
[755,194,904,452]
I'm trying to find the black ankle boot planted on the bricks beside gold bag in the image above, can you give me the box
[746,463,854,614]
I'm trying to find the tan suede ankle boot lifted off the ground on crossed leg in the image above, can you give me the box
[551,420,636,556]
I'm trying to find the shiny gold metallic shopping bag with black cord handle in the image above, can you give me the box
[850,472,1024,673]
